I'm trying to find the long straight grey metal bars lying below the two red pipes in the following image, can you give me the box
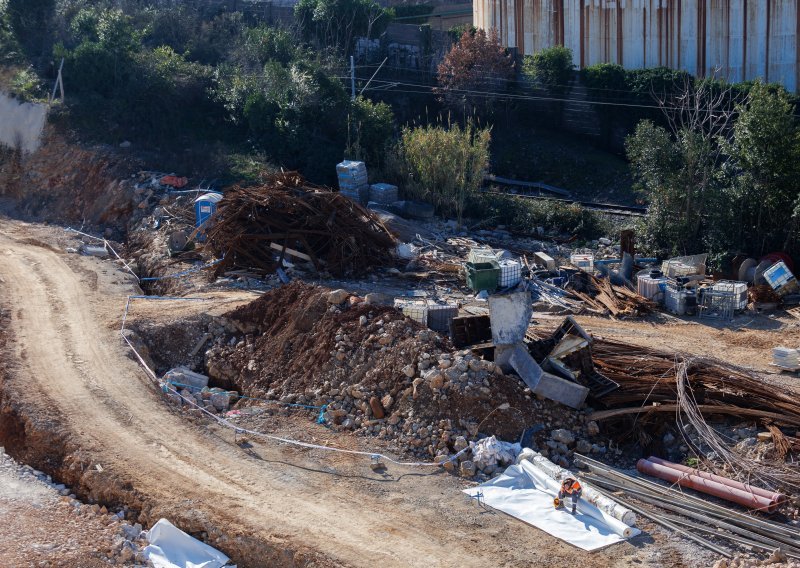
[575,454,800,559]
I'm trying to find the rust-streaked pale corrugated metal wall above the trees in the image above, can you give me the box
[473,0,800,91]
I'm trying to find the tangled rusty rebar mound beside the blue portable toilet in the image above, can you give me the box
[207,172,395,276]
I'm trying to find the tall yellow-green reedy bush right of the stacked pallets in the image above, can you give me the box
[400,123,491,225]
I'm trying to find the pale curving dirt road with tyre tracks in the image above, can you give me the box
[0,218,692,568]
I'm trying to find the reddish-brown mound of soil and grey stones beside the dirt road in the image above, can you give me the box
[198,282,605,476]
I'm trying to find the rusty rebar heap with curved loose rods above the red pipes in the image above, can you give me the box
[589,341,800,487]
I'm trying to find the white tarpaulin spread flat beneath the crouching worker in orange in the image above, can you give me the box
[464,462,641,550]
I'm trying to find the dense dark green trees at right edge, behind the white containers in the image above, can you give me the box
[627,82,800,256]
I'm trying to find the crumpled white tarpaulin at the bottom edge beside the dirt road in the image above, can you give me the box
[143,519,228,568]
